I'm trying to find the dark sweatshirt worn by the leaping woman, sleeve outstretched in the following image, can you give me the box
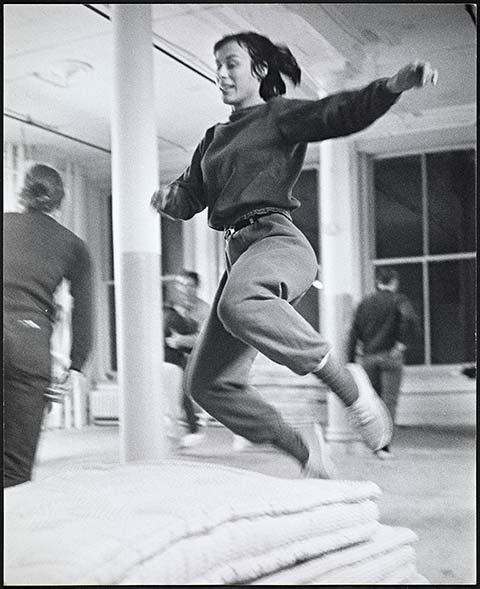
[160,78,400,230]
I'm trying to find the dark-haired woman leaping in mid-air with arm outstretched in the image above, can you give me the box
[151,32,436,478]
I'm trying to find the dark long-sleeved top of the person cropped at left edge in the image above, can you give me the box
[3,212,92,371]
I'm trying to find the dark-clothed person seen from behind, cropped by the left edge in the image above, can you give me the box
[3,164,92,487]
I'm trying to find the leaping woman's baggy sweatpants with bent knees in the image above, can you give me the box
[185,213,329,446]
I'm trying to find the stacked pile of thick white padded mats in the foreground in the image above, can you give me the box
[4,460,427,585]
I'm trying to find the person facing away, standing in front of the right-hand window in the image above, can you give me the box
[347,268,419,460]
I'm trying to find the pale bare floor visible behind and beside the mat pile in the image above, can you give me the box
[35,425,476,585]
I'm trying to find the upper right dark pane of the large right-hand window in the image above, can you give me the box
[426,149,475,254]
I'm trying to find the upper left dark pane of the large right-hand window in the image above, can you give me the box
[374,156,423,258]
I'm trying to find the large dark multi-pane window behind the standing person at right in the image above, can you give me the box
[372,149,476,365]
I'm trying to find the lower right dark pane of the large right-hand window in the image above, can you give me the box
[429,260,475,364]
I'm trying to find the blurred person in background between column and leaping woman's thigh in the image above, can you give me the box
[163,270,209,448]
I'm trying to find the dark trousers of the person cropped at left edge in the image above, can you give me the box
[3,317,51,487]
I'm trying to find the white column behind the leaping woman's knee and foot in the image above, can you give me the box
[320,139,361,448]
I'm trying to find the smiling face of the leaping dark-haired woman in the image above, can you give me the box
[215,41,263,110]
